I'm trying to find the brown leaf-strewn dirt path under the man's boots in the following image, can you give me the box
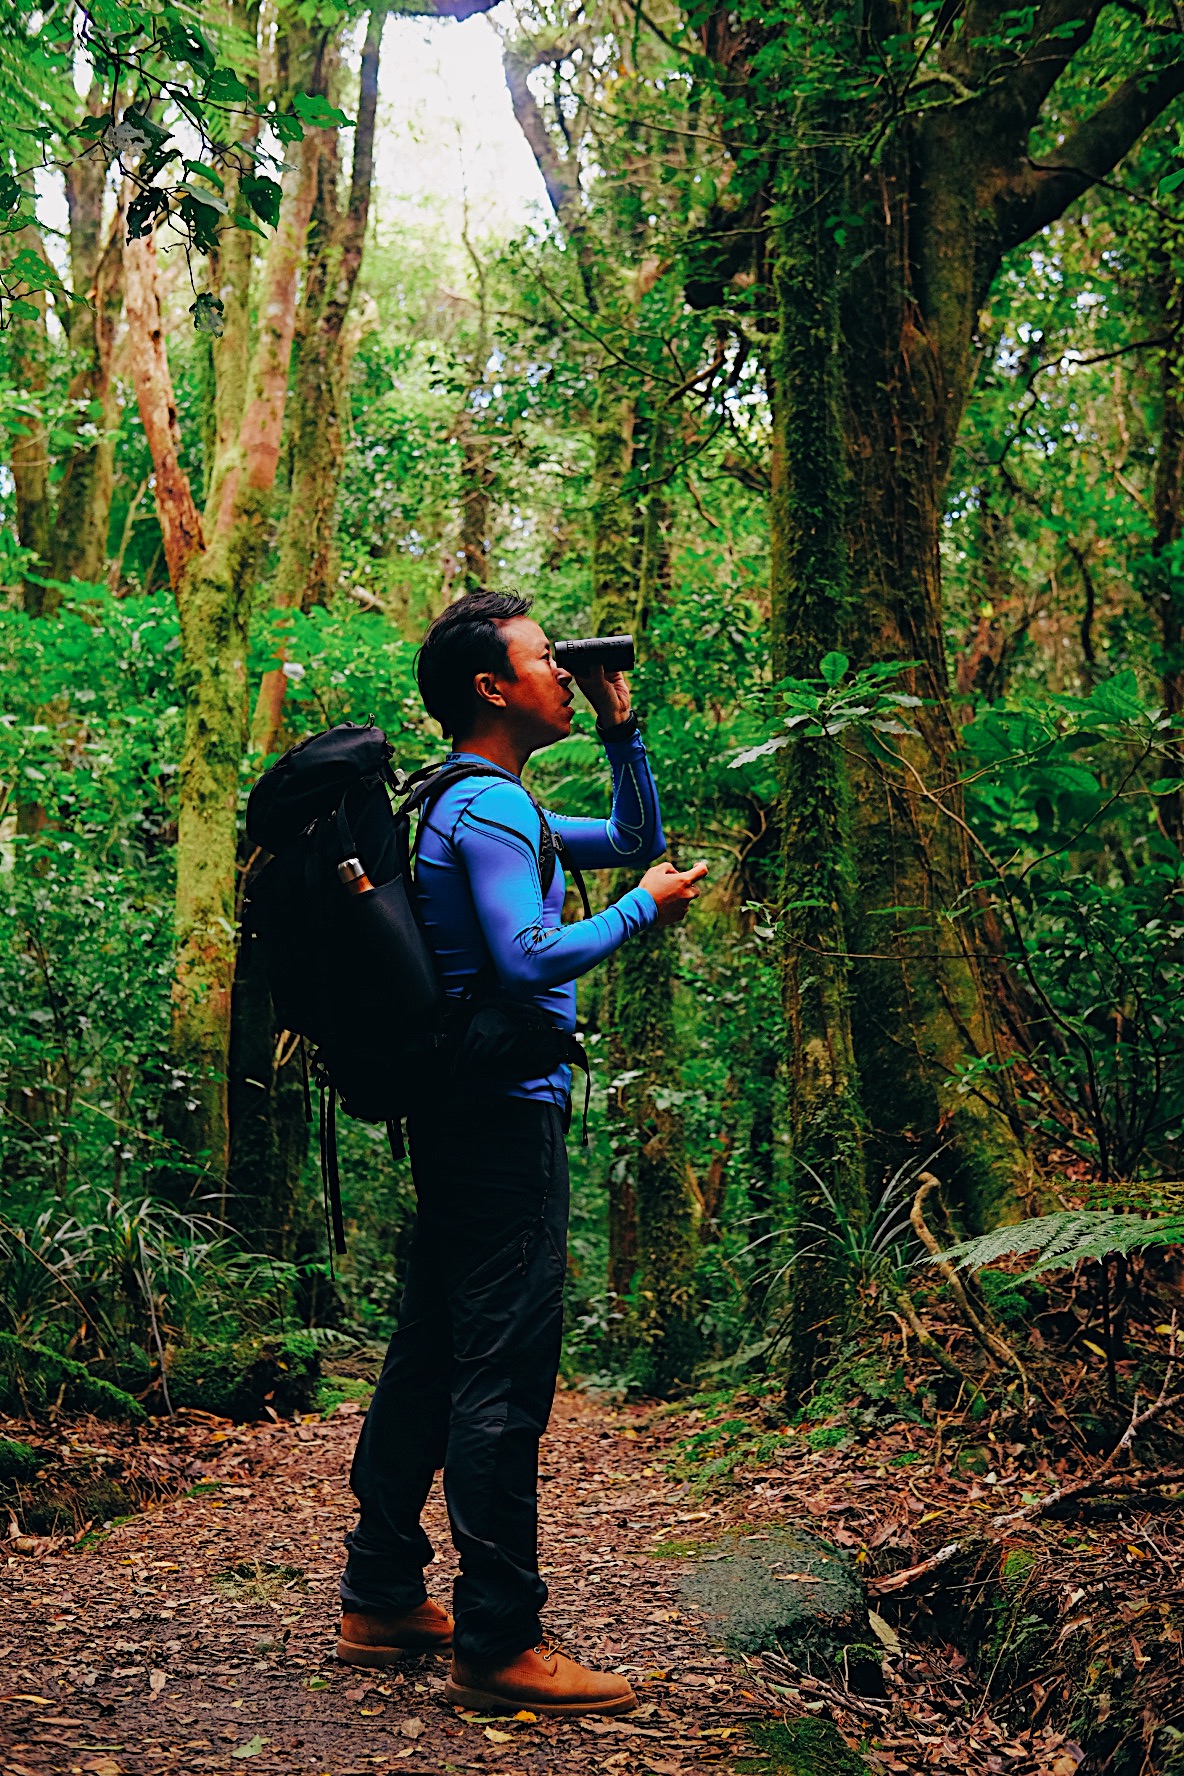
[0,1394,769,1776]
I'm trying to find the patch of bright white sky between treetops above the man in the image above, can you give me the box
[375,16,549,236]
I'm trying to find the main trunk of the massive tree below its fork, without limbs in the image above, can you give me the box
[840,111,1030,1227]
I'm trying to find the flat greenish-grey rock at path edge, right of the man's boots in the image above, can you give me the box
[682,1529,884,1694]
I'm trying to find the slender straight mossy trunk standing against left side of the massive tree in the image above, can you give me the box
[770,153,866,1403]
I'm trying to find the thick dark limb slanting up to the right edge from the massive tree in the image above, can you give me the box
[996,60,1184,250]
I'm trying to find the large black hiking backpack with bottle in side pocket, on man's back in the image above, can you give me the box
[243,719,588,1252]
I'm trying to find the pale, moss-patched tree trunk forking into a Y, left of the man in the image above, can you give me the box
[124,97,316,1199]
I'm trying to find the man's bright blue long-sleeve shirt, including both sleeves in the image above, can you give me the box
[415,730,666,1105]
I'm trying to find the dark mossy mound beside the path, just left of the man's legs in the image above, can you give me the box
[169,1332,321,1423]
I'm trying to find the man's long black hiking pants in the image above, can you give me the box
[341,1098,568,1666]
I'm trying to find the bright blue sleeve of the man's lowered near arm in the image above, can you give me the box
[451,780,657,996]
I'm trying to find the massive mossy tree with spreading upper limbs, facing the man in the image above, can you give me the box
[689,0,1184,1385]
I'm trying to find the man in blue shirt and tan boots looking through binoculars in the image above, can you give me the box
[337,593,706,1714]
